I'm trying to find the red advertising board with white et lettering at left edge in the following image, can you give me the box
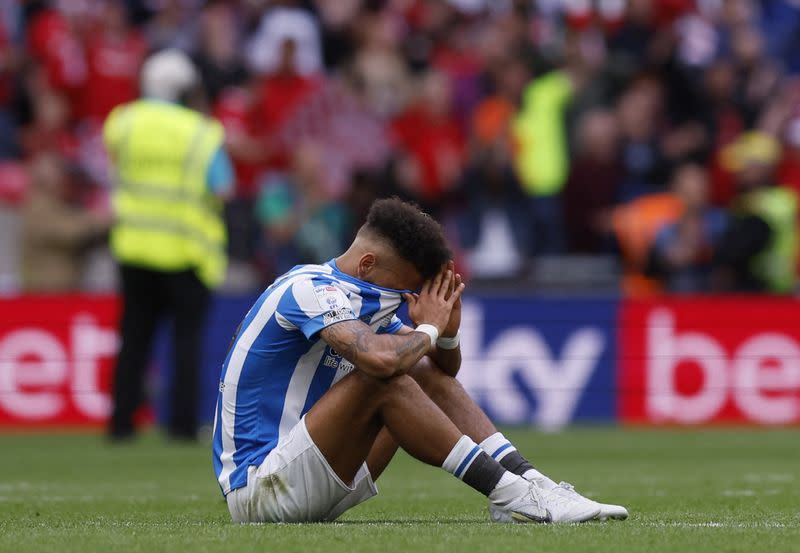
[0,296,119,426]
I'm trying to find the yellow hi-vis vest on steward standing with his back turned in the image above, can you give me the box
[103,100,227,288]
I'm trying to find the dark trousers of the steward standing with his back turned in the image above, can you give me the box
[109,265,211,439]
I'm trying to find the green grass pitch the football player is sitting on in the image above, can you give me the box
[0,428,800,553]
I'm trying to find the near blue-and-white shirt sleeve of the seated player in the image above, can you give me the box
[279,279,356,340]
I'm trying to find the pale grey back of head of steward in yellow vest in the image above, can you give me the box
[142,48,199,102]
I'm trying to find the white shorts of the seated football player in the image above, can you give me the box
[226,417,378,522]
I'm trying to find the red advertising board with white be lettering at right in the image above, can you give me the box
[617,297,800,424]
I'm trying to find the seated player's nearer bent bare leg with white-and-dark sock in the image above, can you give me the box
[305,371,547,521]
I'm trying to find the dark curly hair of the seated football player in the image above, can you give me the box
[365,197,453,279]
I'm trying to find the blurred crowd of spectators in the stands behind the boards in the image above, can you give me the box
[0,0,800,296]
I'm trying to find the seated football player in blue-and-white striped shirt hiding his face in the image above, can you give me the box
[213,199,627,522]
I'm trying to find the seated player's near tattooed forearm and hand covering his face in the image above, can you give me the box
[320,270,463,378]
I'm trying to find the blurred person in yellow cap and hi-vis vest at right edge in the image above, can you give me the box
[717,131,798,294]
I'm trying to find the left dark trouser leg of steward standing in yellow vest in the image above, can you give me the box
[109,265,161,439]
